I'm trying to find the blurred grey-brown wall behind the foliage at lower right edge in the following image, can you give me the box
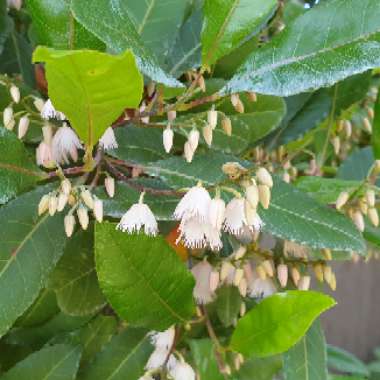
[322,260,380,361]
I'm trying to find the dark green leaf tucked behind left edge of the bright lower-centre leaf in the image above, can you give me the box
[49,230,105,316]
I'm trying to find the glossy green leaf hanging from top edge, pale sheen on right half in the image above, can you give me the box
[202,0,277,66]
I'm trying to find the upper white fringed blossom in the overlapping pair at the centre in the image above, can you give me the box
[174,185,211,222]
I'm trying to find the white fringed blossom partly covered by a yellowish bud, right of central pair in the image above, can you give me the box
[224,198,263,235]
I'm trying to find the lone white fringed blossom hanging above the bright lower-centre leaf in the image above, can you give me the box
[117,193,158,236]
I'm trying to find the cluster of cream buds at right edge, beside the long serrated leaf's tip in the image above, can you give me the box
[336,189,379,232]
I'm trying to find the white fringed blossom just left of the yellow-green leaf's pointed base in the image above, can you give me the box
[52,124,83,164]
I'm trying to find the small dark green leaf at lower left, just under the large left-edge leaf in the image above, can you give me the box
[16,289,59,327]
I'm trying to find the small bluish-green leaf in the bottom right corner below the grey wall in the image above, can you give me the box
[327,345,369,377]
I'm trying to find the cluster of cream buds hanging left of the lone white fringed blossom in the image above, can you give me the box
[38,178,103,237]
